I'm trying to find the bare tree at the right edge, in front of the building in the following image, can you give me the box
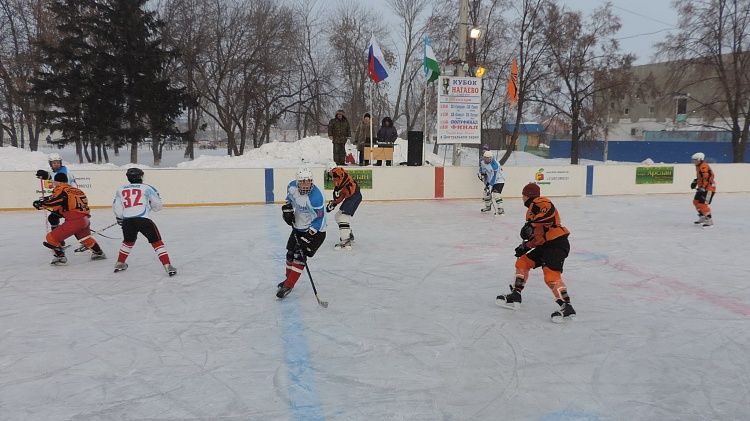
[657,0,750,162]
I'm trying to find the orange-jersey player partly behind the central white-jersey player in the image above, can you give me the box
[326,162,362,250]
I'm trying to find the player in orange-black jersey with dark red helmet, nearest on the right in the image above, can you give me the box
[496,183,576,323]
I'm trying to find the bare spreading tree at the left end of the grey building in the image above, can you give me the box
[530,3,634,165]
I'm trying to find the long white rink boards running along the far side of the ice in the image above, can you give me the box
[0,164,750,210]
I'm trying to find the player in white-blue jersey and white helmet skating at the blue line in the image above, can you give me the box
[276,168,326,298]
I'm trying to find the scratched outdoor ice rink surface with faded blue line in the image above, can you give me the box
[0,193,750,421]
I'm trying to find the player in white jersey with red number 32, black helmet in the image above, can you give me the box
[112,168,177,276]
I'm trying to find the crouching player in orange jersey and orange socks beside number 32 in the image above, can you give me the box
[33,173,106,266]
